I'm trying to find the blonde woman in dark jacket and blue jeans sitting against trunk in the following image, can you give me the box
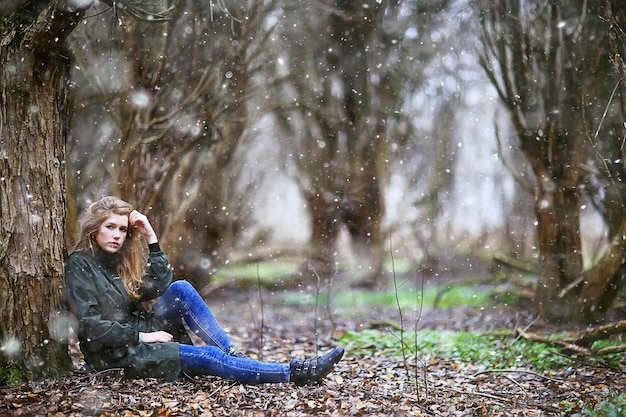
[66,197,343,385]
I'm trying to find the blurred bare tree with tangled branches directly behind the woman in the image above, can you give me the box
[66,1,274,288]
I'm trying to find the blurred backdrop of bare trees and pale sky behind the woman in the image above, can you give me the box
[67,0,624,324]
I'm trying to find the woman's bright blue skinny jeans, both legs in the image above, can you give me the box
[154,281,289,384]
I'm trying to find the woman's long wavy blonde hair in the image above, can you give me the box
[74,196,146,299]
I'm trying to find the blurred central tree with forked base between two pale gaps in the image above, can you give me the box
[267,1,396,285]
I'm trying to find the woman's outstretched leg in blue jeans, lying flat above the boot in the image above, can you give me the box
[179,344,290,384]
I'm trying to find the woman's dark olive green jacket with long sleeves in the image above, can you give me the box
[65,244,180,380]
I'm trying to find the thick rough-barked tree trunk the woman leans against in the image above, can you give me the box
[0,1,81,379]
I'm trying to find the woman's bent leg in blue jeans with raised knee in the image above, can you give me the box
[154,281,233,352]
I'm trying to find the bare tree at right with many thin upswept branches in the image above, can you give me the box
[477,0,625,322]
